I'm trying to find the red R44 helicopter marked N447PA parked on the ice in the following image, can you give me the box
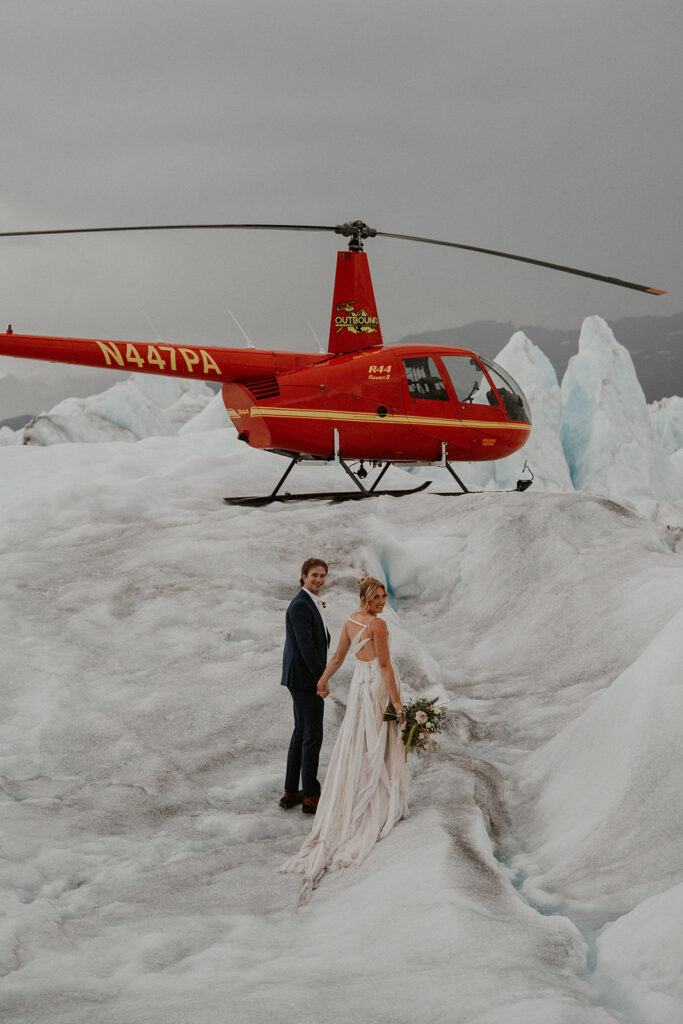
[0,220,666,505]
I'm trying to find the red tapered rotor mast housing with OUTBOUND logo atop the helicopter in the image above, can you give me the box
[328,252,383,354]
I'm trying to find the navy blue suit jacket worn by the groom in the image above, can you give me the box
[282,588,330,693]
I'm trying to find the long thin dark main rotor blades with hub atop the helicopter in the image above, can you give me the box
[0,220,667,295]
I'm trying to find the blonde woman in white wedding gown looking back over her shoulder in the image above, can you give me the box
[281,577,408,904]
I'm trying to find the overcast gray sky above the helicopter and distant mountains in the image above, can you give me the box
[0,0,683,360]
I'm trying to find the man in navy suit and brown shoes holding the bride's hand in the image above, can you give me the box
[280,558,330,814]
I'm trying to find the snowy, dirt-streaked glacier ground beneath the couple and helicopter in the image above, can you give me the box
[0,417,683,1024]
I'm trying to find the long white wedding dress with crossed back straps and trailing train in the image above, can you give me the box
[280,618,409,904]
